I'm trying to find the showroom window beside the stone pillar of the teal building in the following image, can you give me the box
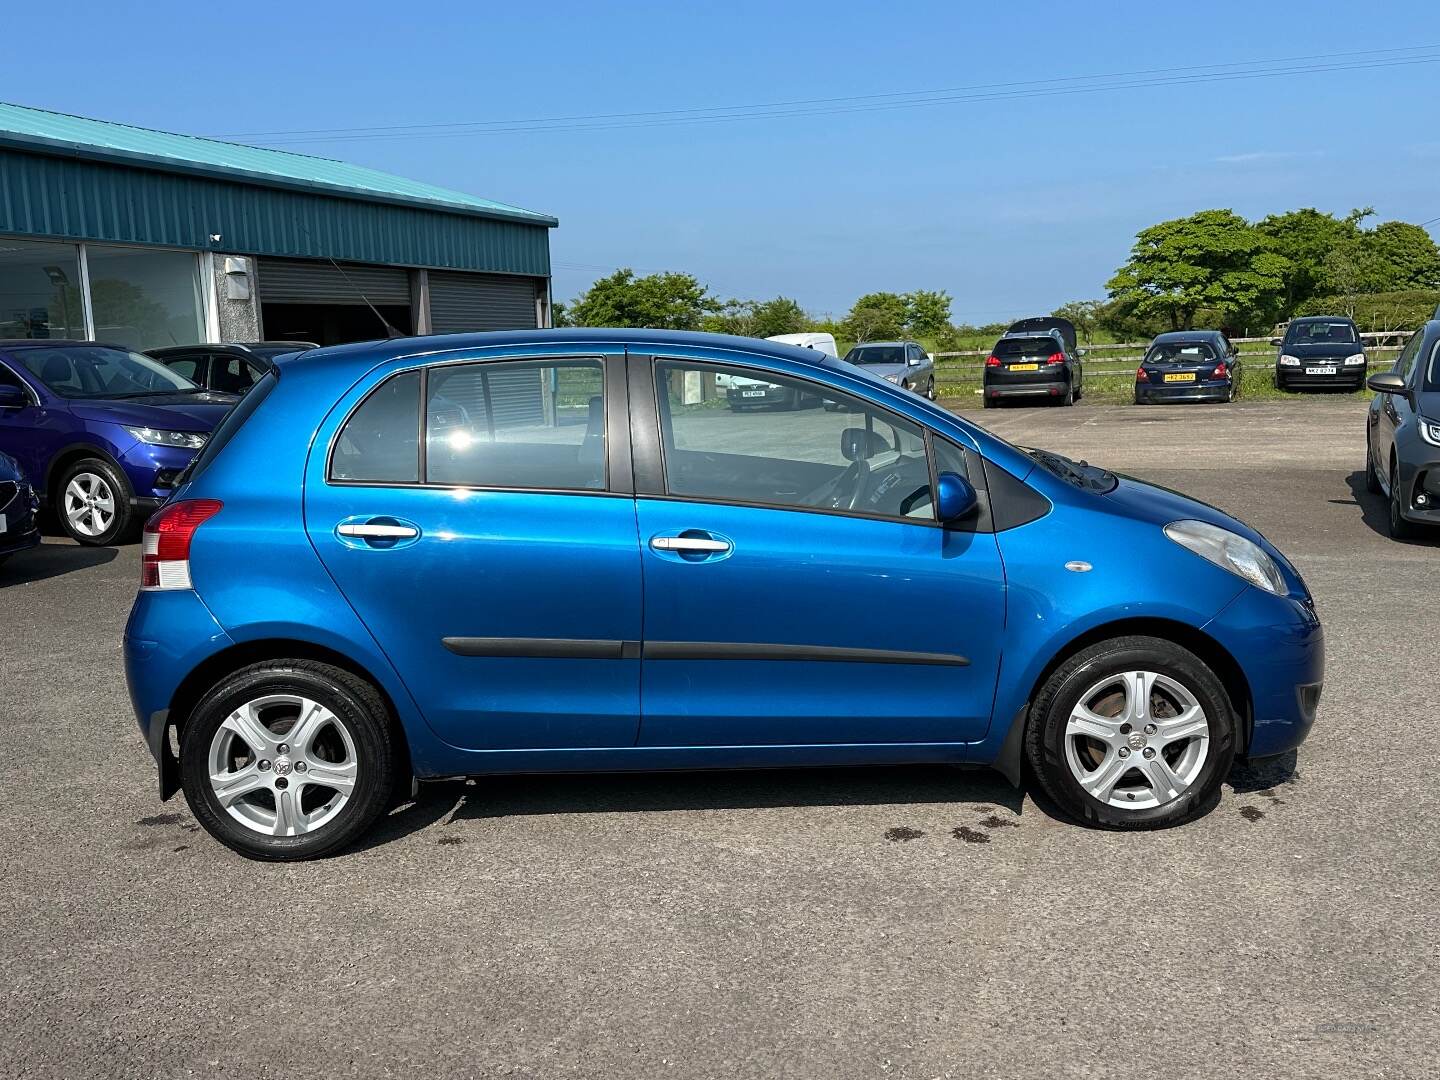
[85,243,204,351]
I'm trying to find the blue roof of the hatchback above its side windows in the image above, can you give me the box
[275,327,838,374]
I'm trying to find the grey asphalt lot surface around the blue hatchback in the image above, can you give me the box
[0,399,1440,1080]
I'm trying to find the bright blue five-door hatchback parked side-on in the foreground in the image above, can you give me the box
[125,330,1323,860]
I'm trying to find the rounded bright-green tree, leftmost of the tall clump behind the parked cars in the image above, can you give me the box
[1106,210,1290,330]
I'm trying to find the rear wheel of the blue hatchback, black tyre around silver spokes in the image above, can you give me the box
[180,660,397,863]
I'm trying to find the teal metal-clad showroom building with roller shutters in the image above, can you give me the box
[0,104,557,348]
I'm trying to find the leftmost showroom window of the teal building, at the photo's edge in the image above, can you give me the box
[0,238,85,338]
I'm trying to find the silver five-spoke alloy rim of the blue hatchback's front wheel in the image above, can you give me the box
[1064,671,1210,809]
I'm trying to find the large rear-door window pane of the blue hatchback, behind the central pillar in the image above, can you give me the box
[425,360,605,491]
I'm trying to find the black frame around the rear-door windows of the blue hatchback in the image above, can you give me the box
[324,353,624,498]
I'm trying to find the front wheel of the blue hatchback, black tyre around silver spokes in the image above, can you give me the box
[1025,636,1237,829]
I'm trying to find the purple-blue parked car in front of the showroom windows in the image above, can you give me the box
[0,340,239,544]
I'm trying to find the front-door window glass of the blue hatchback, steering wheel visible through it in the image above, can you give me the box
[655,361,935,520]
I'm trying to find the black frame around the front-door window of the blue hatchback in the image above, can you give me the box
[650,356,946,530]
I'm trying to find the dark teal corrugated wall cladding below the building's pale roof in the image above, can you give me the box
[0,150,550,279]
